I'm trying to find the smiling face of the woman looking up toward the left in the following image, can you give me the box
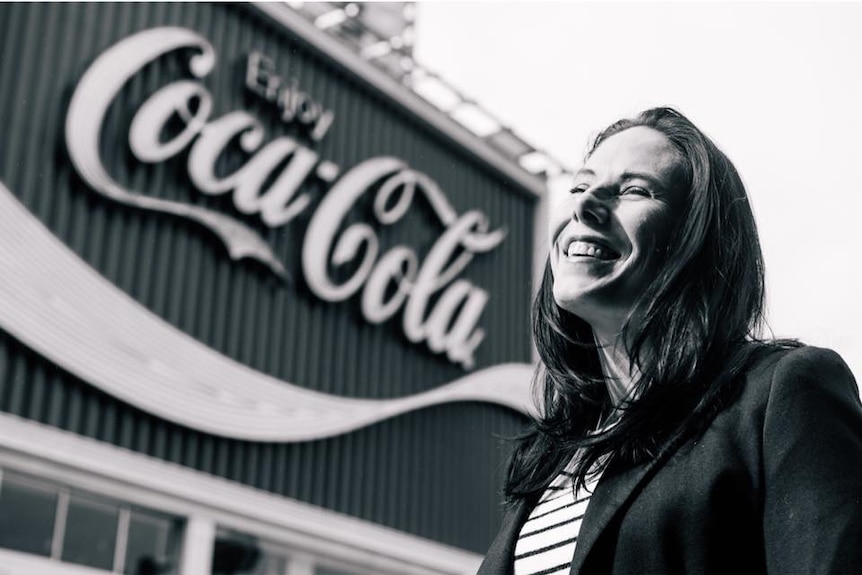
[548,126,685,337]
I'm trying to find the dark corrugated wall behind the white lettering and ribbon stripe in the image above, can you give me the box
[0,3,534,552]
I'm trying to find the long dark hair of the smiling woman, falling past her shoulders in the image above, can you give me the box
[505,108,796,501]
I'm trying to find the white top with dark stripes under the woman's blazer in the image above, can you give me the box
[515,461,599,575]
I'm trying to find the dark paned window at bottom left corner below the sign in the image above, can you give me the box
[0,473,182,575]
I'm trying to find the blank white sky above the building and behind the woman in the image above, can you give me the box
[414,2,862,380]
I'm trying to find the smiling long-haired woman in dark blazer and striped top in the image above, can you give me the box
[480,108,862,574]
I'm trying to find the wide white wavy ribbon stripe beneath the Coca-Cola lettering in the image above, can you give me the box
[0,183,534,442]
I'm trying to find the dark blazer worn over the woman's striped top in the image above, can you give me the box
[479,347,862,575]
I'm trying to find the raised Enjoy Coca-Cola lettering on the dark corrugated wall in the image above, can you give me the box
[65,27,506,369]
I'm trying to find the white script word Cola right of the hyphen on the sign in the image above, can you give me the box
[302,158,505,368]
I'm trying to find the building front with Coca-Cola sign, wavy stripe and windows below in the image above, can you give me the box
[0,3,544,575]
